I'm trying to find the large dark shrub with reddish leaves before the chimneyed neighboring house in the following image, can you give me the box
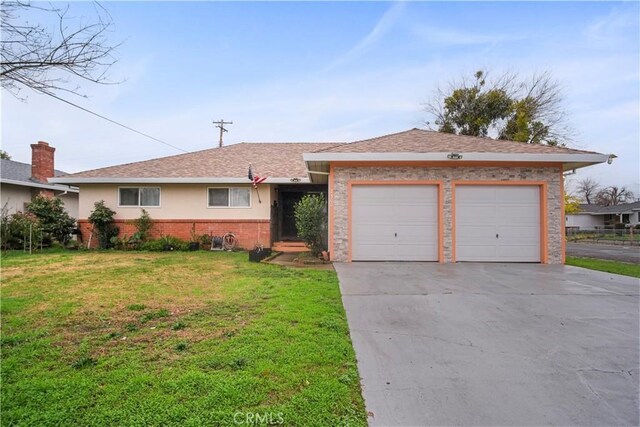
[26,195,76,245]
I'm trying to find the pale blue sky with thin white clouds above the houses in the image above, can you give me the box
[2,2,640,193]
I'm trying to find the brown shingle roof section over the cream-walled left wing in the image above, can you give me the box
[68,142,338,178]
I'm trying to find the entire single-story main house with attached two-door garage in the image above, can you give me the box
[54,129,609,264]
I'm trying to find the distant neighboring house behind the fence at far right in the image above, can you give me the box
[566,202,640,229]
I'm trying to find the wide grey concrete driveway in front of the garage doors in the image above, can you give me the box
[335,263,640,426]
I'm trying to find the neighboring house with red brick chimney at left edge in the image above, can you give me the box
[0,141,78,218]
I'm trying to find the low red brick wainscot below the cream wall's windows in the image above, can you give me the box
[78,219,271,249]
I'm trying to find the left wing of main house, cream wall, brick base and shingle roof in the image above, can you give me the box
[50,143,336,249]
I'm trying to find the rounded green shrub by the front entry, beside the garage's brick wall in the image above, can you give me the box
[294,194,327,256]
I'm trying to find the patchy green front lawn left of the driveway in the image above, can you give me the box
[1,252,366,426]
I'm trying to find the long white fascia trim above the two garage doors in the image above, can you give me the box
[302,152,609,164]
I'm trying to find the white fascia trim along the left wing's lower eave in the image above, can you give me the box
[50,177,311,185]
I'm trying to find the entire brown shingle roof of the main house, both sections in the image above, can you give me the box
[58,129,604,179]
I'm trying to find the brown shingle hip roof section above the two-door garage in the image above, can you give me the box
[322,128,594,154]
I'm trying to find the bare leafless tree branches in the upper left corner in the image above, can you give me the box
[0,0,117,98]
